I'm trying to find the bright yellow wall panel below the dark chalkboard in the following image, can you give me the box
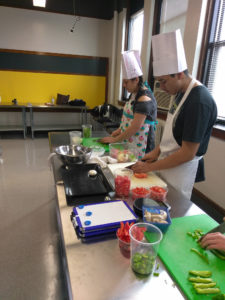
[0,71,106,108]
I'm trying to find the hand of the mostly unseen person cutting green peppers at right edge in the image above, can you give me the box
[200,232,225,251]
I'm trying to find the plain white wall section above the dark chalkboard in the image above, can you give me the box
[0,6,112,57]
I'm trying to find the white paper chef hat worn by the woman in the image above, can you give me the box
[122,50,143,79]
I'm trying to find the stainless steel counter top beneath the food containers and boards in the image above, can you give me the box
[50,134,203,300]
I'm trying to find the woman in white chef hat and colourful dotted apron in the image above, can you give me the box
[101,50,157,159]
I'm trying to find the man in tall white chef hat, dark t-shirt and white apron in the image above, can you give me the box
[132,30,217,200]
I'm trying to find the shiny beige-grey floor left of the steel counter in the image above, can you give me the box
[0,137,67,300]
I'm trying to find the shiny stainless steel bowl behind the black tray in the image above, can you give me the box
[55,145,92,165]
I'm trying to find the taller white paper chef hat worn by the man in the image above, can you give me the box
[152,29,187,76]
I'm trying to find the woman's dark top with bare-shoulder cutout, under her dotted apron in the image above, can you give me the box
[133,89,157,153]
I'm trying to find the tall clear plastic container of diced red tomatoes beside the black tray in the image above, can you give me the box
[114,168,133,198]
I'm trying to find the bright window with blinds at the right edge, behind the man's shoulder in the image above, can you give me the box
[202,0,225,122]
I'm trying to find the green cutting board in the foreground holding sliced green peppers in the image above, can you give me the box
[158,215,225,300]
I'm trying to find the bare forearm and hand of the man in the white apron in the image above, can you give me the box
[132,141,199,173]
